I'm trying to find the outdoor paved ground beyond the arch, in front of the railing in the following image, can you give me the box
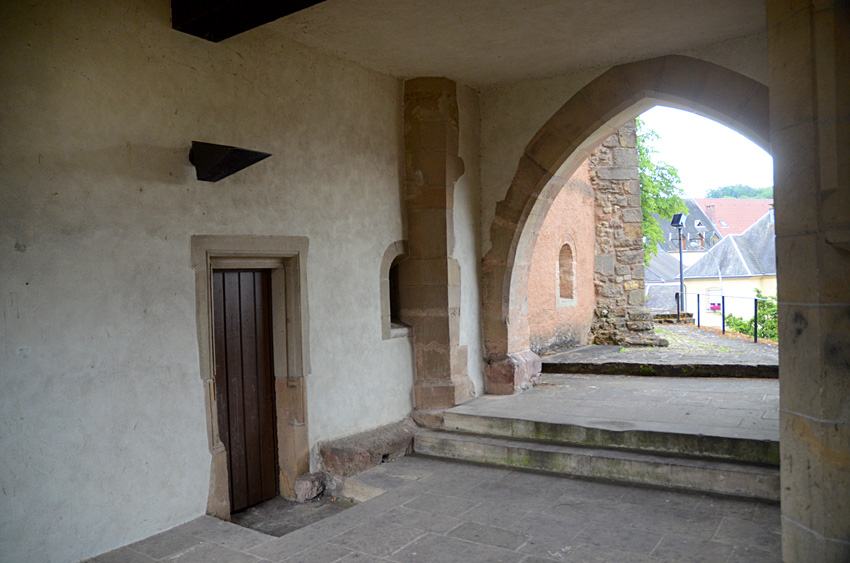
[543,325,779,366]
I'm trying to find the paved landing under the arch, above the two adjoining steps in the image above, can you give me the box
[449,374,779,441]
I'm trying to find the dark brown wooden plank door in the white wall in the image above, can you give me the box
[213,270,278,512]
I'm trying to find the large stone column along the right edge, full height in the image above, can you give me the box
[766,0,850,562]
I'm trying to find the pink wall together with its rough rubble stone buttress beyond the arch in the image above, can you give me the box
[528,122,660,354]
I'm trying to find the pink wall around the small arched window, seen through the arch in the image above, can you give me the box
[528,161,596,354]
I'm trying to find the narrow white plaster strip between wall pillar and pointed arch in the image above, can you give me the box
[453,84,484,395]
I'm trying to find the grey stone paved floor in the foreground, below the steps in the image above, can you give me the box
[84,456,780,563]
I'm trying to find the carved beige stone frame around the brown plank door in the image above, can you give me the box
[191,235,310,520]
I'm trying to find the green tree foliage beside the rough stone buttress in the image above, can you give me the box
[636,117,688,264]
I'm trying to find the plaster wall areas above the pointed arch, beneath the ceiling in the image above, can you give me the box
[480,34,768,254]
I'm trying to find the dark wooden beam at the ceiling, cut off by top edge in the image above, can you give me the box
[171,0,322,43]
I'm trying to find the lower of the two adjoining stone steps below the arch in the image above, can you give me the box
[414,430,779,501]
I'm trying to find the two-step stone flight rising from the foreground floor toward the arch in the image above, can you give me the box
[414,406,779,501]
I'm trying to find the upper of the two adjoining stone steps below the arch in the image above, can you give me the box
[443,411,779,466]
